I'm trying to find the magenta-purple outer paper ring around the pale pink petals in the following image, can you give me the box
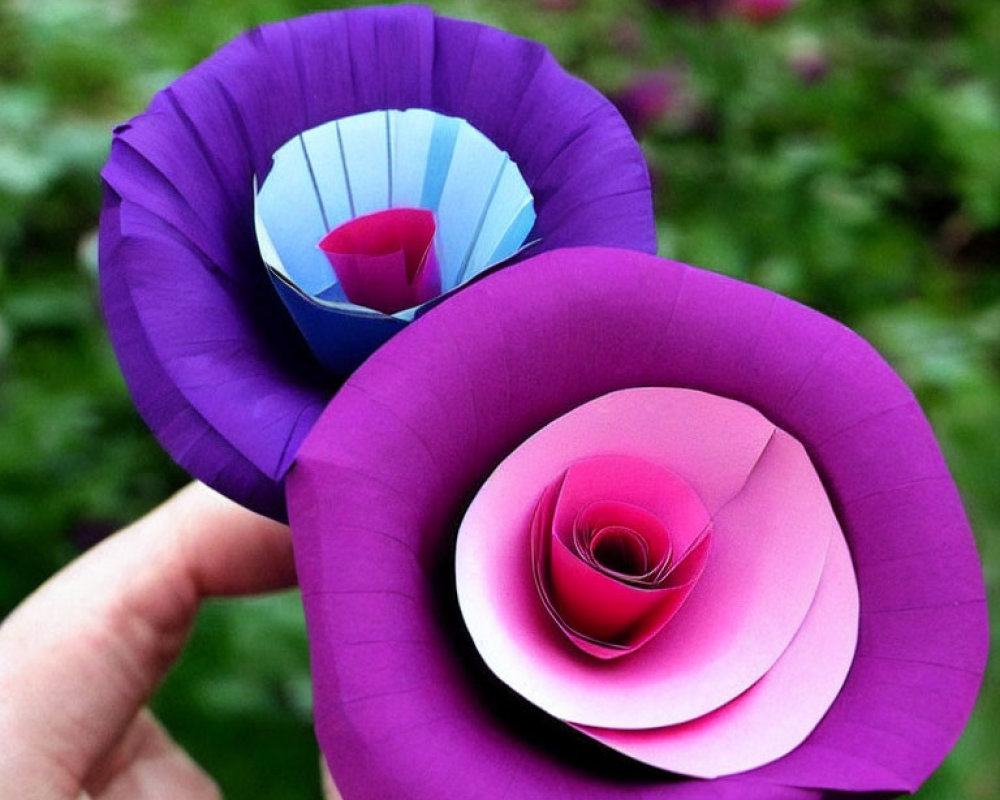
[288,248,987,800]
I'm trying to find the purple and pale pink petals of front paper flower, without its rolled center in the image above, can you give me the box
[288,248,987,800]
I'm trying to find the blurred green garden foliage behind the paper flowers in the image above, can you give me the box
[0,0,1000,800]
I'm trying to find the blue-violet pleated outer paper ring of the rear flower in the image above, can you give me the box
[100,6,656,518]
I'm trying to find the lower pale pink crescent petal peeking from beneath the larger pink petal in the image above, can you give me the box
[581,526,859,778]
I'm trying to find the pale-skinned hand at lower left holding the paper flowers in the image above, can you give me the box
[0,484,340,800]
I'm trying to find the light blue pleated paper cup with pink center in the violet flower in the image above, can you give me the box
[254,108,535,375]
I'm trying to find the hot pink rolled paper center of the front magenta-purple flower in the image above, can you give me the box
[531,455,710,659]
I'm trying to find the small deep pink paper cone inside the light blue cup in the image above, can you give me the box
[319,208,441,314]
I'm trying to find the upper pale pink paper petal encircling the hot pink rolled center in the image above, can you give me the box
[456,388,835,729]
